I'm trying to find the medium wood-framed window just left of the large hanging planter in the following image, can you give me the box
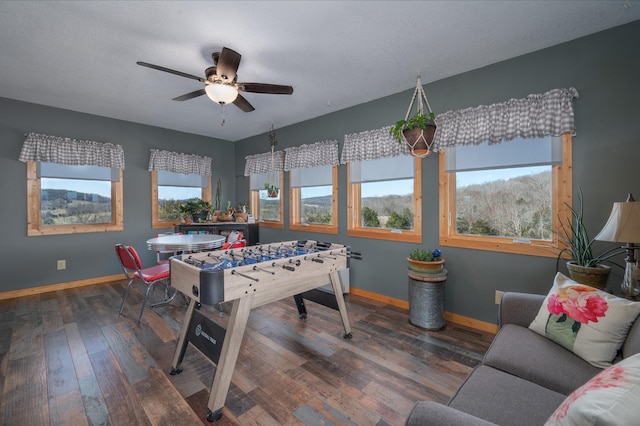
[347,155,422,243]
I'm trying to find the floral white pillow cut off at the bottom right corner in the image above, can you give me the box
[545,354,640,426]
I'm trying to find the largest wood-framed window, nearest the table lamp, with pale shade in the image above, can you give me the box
[439,133,572,257]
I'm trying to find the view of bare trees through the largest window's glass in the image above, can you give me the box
[456,166,552,240]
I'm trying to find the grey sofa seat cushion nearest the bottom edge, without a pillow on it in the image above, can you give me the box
[449,365,566,426]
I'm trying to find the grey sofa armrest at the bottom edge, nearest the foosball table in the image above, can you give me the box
[405,401,496,426]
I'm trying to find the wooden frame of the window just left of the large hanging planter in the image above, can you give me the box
[347,158,422,244]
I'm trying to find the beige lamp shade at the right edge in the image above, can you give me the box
[595,201,640,243]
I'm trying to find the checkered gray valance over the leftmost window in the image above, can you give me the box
[18,133,124,169]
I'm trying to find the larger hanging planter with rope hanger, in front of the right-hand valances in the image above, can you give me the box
[391,76,437,158]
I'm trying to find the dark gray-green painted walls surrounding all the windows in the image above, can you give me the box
[0,21,640,322]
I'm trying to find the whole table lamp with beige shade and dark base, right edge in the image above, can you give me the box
[595,194,640,298]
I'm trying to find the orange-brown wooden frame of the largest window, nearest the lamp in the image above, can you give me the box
[439,133,572,257]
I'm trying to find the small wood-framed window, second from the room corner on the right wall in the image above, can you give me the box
[289,166,338,234]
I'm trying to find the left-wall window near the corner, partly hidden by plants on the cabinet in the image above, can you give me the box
[151,170,211,229]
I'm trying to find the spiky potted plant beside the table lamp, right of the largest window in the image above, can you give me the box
[556,189,624,290]
